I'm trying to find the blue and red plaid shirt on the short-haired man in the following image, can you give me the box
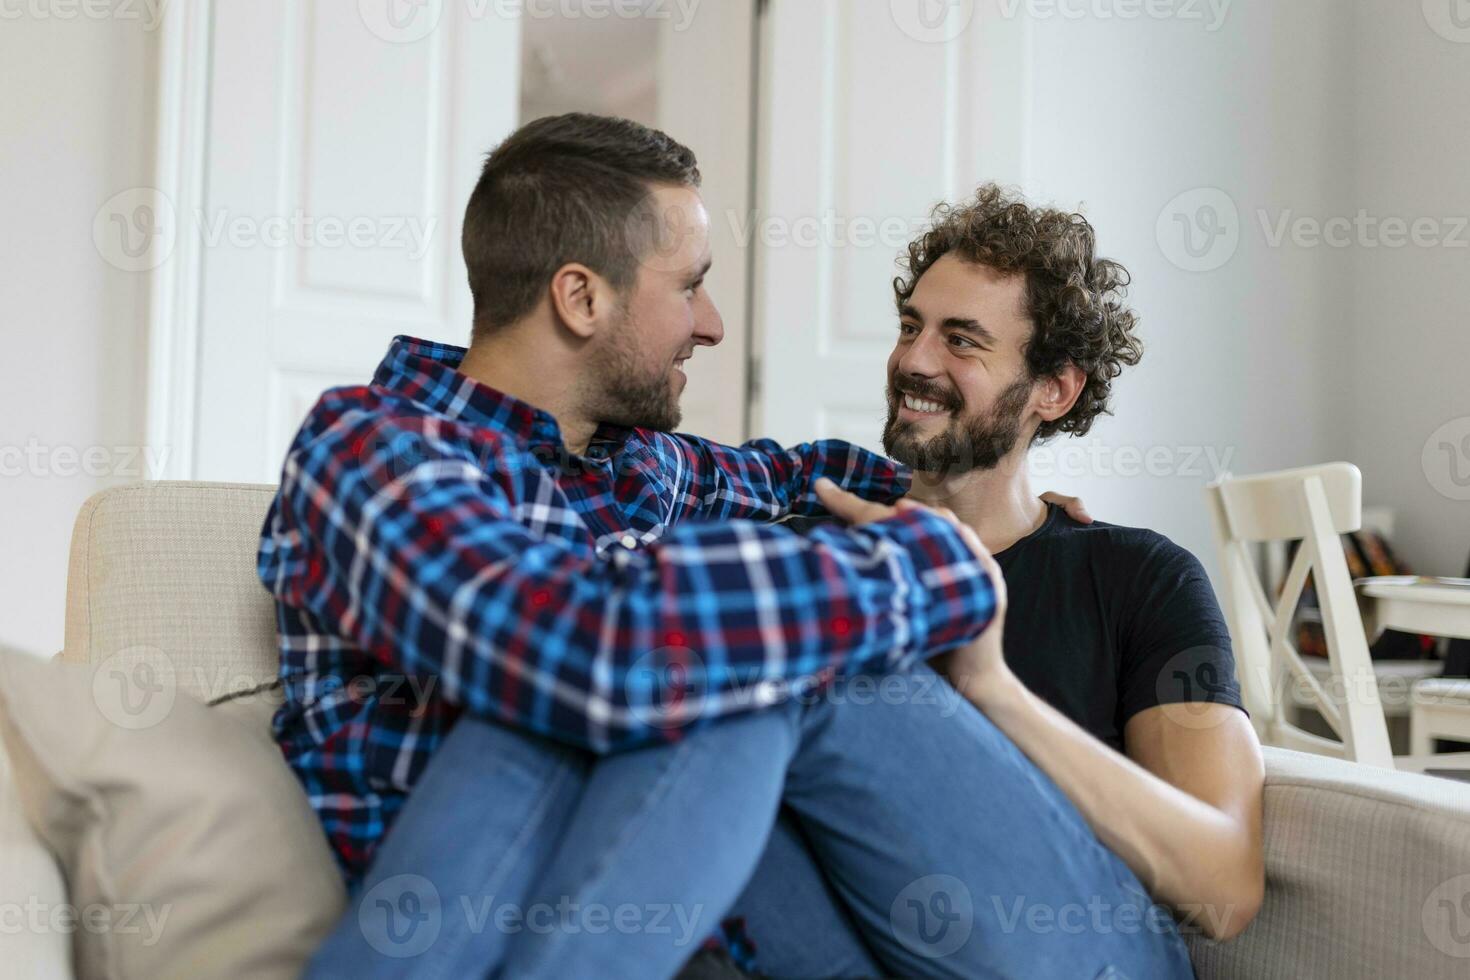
[257,336,994,879]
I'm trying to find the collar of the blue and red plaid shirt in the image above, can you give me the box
[373,336,631,458]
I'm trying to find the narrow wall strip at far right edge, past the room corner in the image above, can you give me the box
[1338,3,1470,574]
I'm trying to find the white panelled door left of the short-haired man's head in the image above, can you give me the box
[153,0,520,482]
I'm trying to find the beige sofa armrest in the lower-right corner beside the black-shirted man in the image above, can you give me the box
[1186,748,1470,980]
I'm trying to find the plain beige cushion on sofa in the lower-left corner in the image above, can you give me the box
[0,655,344,979]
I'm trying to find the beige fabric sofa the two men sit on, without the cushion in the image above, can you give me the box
[0,483,1470,980]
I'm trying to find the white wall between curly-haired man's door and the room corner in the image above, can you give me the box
[1023,0,1352,570]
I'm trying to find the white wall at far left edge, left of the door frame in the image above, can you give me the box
[0,11,156,655]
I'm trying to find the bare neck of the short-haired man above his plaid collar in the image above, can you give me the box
[459,323,597,455]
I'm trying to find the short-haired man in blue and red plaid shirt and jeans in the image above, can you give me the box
[259,115,1189,976]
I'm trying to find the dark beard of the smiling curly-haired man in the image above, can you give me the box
[883,372,1032,478]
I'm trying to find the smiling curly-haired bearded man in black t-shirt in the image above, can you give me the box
[739,185,1264,973]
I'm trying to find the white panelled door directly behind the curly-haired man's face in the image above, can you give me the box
[751,0,1030,450]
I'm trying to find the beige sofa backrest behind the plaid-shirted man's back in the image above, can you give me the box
[62,482,279,702]
